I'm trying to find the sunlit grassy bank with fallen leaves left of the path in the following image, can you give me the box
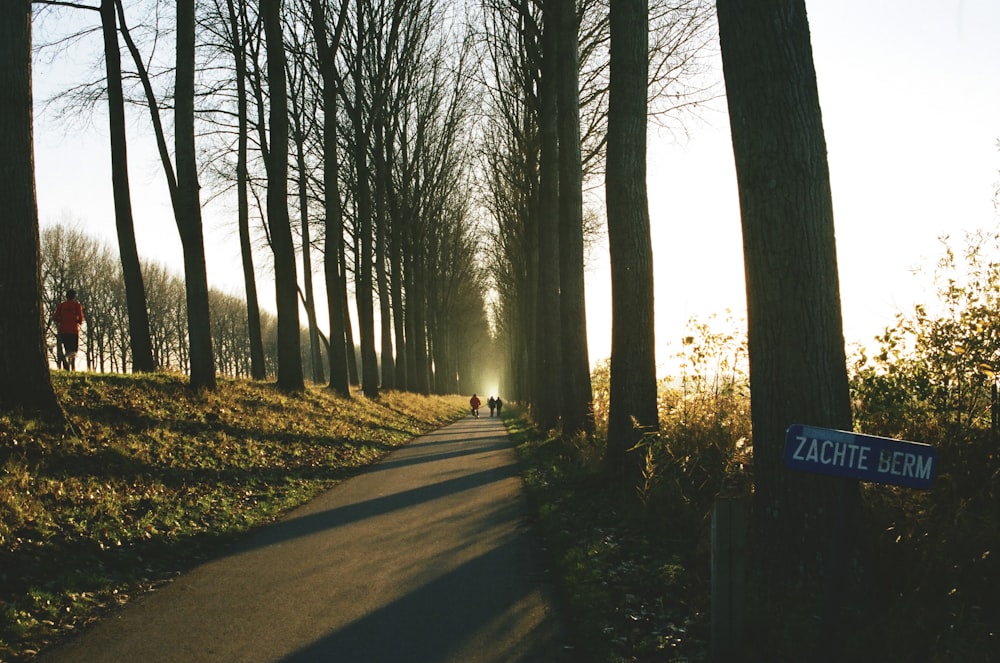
[0,373,466,661]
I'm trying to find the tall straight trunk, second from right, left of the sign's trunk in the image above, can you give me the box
[605,0,659,486]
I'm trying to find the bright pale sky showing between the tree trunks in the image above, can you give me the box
[34,0,1000,375]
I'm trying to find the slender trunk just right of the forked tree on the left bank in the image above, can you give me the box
[227,0,267,380]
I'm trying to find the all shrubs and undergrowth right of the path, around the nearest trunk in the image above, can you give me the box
[514,234,1000,663]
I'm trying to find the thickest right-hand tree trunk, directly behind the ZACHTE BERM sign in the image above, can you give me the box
[717,0,863,660]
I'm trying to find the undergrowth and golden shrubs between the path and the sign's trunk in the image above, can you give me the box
[508,334,750,663]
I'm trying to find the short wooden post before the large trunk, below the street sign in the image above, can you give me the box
[711,496,750,663]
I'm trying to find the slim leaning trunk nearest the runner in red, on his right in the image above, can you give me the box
[101,0,156,372]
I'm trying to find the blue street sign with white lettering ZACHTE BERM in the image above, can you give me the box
[785,424,937,488]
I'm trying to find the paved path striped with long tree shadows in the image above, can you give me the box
[39,417,570,663]
